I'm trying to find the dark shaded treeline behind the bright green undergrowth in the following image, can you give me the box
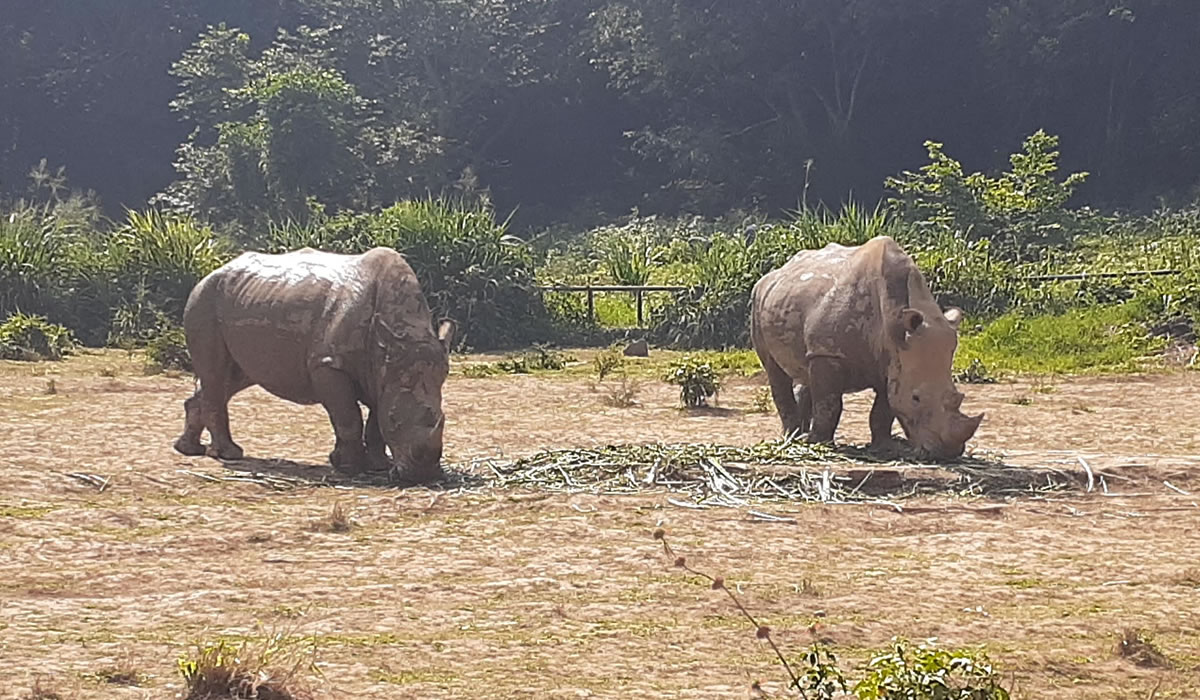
[0,0,1200,229]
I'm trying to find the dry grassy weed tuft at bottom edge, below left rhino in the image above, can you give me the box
[178,633,319,700]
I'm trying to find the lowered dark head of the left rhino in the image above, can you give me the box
[377,321,455,483]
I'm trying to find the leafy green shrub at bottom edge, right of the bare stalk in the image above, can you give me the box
[854,640,1009,700]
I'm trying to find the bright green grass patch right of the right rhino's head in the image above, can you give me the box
[954,304,1163,375]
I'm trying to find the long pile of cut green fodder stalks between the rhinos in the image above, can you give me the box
[482,438,1079,504]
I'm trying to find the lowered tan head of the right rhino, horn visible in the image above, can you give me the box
[888,306,983,459]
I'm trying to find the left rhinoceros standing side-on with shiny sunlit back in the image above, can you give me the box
[168,247,454,481]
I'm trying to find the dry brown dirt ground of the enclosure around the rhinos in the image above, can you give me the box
[0,352,1200,699]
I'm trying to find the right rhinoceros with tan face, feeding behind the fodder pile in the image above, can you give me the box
[750,237,983,459]
